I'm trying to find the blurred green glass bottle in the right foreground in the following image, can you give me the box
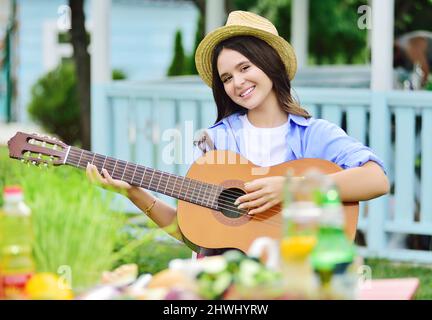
[311,180,358,299]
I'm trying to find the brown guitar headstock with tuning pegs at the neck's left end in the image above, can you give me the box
[8,132,69,166]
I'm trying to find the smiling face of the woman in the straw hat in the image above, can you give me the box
[217,48,276,110]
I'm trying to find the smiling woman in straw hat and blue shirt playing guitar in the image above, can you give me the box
[87,11,389,250]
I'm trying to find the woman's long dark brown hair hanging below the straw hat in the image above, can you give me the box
[212,36,311,122]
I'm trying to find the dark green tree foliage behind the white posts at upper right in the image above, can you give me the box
[231,0,432,64]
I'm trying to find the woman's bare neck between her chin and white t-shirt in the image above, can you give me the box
[247,91,288,128]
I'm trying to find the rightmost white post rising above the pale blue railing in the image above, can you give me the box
[371,0,394,91]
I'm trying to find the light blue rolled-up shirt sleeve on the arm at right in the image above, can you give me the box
[306,119,386,172]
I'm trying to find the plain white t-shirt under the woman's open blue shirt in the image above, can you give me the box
[240,114,288,167]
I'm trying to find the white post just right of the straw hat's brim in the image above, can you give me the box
[291,0,309,68]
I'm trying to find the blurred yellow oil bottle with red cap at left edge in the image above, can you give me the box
[0,186,35,299]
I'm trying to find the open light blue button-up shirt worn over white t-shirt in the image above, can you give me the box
[194,113,385,171]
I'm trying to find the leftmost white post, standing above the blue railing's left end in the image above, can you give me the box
[91,0,111,84]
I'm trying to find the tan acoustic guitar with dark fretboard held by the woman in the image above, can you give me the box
[8,132,358,252]
